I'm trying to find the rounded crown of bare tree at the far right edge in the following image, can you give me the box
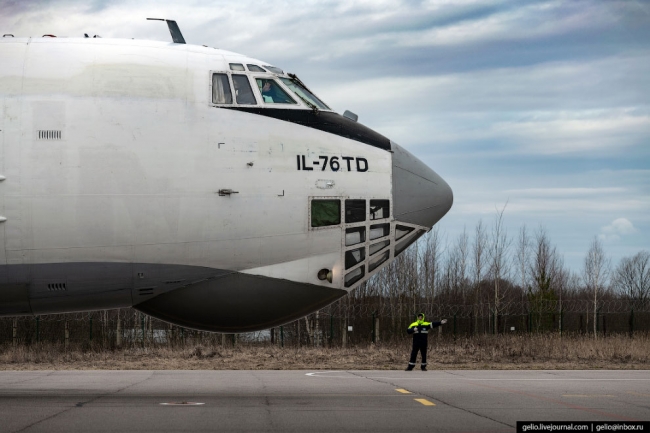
[614,251,650,306]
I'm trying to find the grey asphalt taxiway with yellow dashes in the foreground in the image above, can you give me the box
[0,370,650,433]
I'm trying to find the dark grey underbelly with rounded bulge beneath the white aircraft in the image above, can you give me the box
[0,263,346,333]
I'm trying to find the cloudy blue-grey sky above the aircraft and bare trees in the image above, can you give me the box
[0,0,650,271]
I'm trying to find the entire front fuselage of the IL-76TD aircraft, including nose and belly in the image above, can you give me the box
[0,38,452,332]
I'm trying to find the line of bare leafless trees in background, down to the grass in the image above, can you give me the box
[0,211,650,348]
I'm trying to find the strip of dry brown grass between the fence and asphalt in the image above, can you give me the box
[0,335,650,370]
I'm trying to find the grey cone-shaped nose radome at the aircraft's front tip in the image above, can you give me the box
[391,143,454,227]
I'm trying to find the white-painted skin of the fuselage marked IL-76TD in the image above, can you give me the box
[0,38,392,288]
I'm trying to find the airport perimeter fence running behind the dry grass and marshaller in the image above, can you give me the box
[0,300,650,350]
